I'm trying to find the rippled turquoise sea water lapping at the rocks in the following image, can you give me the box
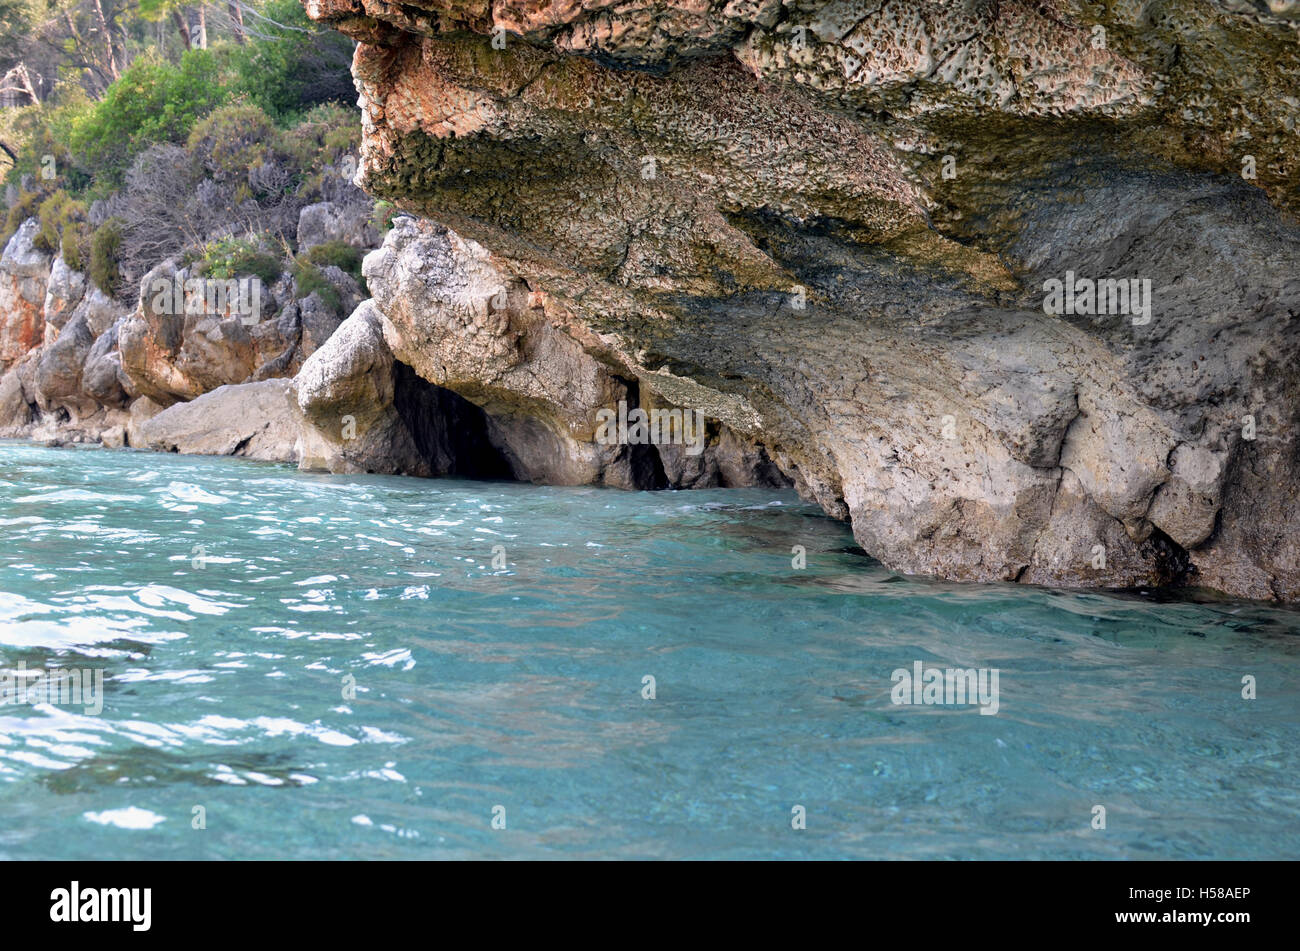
[0,443,1300,859]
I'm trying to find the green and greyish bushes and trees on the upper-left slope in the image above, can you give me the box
[0,0,368,307]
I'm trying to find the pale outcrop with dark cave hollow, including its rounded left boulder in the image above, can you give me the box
[298,218,787,488]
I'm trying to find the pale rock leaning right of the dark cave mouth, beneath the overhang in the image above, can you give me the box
[340,218,788,488]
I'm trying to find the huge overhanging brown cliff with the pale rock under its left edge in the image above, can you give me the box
[306,0,1300,600]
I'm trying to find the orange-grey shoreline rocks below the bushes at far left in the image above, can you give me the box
[0,203,378,452]
